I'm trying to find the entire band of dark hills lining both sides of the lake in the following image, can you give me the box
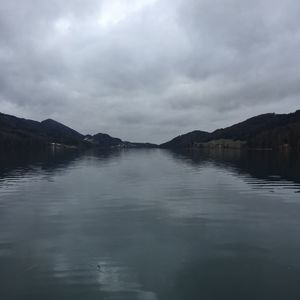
[0,110,300,150]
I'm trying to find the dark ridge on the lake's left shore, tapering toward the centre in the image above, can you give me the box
[0,113,156,149]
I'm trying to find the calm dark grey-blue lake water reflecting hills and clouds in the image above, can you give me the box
[0,150,300,300]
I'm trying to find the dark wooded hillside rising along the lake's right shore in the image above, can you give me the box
[160,110,300,149]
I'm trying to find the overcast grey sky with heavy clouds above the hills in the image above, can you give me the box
[0,0,300,143]
